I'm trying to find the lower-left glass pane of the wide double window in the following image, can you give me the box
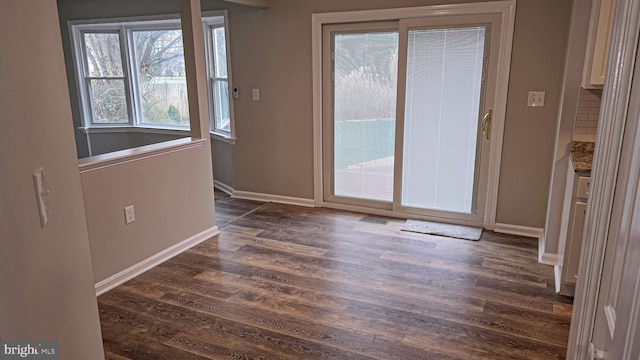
[89,79,129,123]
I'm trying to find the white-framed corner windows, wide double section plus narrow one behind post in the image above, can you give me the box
[70,14,233,138]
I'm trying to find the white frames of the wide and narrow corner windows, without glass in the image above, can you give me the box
[68,10,235,139]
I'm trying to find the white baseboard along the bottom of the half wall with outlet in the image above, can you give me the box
[95,226,220,296]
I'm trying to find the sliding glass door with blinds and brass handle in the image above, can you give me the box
[324,15,497,223]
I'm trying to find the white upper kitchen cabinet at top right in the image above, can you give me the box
[582,0,616,89]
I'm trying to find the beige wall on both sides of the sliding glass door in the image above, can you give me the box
[230,0,572,228]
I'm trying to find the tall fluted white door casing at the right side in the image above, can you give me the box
[567,0,640,360]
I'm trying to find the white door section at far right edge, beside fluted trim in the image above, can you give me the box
[604,40,640,360]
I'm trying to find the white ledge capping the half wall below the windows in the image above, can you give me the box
[78,138,207,174]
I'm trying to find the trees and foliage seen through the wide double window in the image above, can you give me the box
[85,30,188,125]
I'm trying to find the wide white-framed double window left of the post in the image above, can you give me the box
[72,20,189,129]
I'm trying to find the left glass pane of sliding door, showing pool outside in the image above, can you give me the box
[333,32,398,202]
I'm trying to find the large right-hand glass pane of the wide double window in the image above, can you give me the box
[133,30,189,126]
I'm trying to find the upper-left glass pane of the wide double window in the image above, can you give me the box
[84,33,123,77]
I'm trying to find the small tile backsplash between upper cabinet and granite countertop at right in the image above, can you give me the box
[573,88,602,141]
